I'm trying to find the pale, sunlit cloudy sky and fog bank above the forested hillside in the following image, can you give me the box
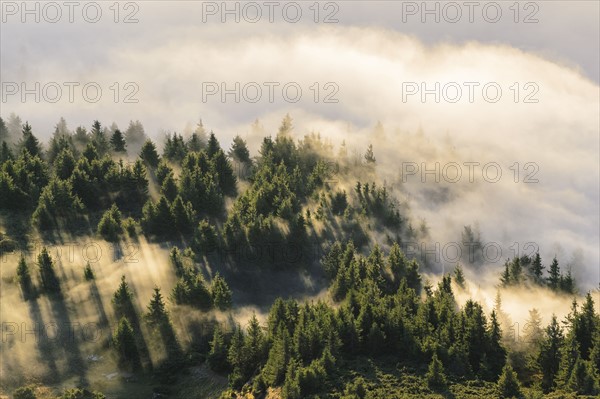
[0,1,600,288]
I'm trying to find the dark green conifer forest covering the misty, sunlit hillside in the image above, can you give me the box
[0,114,600,399]
